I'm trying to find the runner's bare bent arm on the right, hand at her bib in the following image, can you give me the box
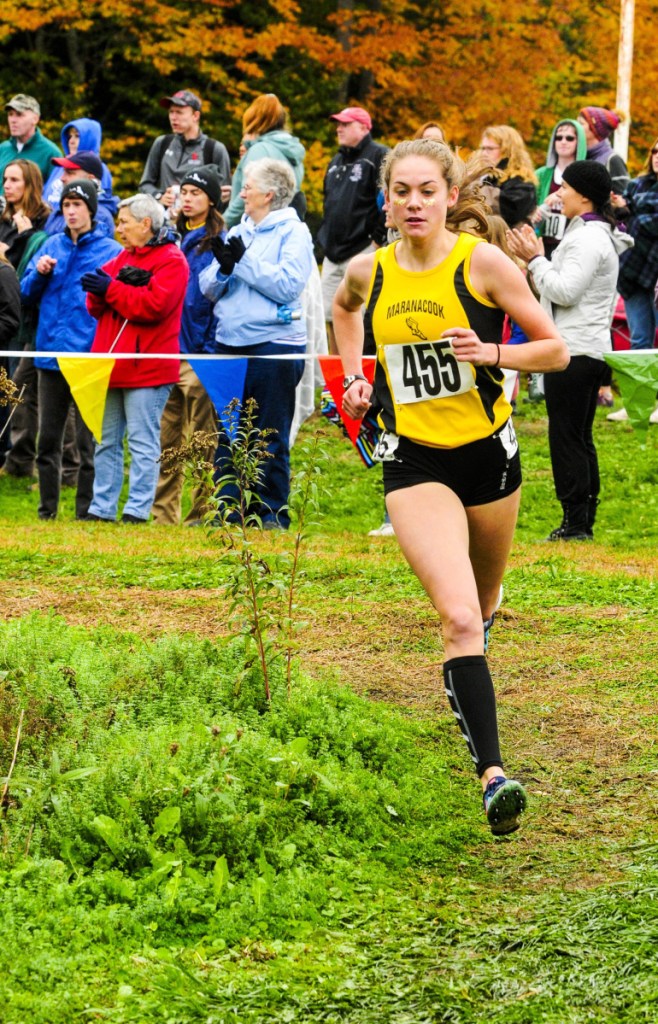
[443,245,569,373]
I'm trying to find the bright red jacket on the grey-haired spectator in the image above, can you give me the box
[87,233,189,388]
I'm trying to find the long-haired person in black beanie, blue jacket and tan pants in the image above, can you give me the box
[151,165,224,524]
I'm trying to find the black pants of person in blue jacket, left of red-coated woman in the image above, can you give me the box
[37,370,94,519]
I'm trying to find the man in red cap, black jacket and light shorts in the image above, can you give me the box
[317,106,388,352]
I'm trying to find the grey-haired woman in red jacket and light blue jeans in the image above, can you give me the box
[82,195,188,523]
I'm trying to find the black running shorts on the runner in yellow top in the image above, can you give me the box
[379,420,521,507]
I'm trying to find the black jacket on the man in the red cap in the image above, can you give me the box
[317,132,388,263]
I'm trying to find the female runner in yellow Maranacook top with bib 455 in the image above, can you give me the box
[334,139,569,835]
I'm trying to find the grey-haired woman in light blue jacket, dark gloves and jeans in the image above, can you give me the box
[200,159,314,529]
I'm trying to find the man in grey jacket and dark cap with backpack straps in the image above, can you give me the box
[139,89,231,209]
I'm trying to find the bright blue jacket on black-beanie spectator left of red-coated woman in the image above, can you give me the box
[20,228,121,370]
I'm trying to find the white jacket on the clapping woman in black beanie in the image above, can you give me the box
[529,217,632,359]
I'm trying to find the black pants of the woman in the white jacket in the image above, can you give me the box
[543,355,606,505]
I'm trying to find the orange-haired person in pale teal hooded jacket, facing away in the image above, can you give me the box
[222,92,306,227]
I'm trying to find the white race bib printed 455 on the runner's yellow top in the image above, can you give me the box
[384,338,475,406]
